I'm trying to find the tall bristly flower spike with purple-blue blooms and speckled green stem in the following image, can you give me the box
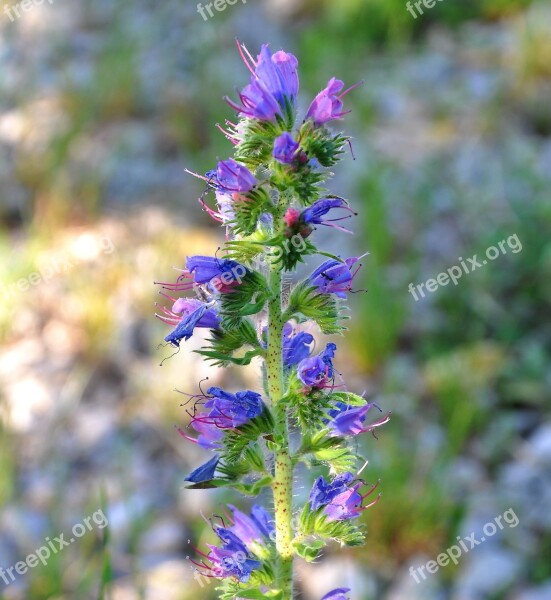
[153,44,389,600]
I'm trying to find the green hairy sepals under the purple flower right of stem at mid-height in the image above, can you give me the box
[283,279,345,335]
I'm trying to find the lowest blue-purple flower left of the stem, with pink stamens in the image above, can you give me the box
[206,527,262,583]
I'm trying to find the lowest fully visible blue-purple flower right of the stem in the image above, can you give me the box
[310,473,380,521]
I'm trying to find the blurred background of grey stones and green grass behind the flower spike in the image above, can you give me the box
[0,0,551,600]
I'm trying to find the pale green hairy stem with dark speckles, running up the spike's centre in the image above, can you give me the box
[266,266,293,600]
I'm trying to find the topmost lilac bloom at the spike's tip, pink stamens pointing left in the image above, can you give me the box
[226,44,298,121]
